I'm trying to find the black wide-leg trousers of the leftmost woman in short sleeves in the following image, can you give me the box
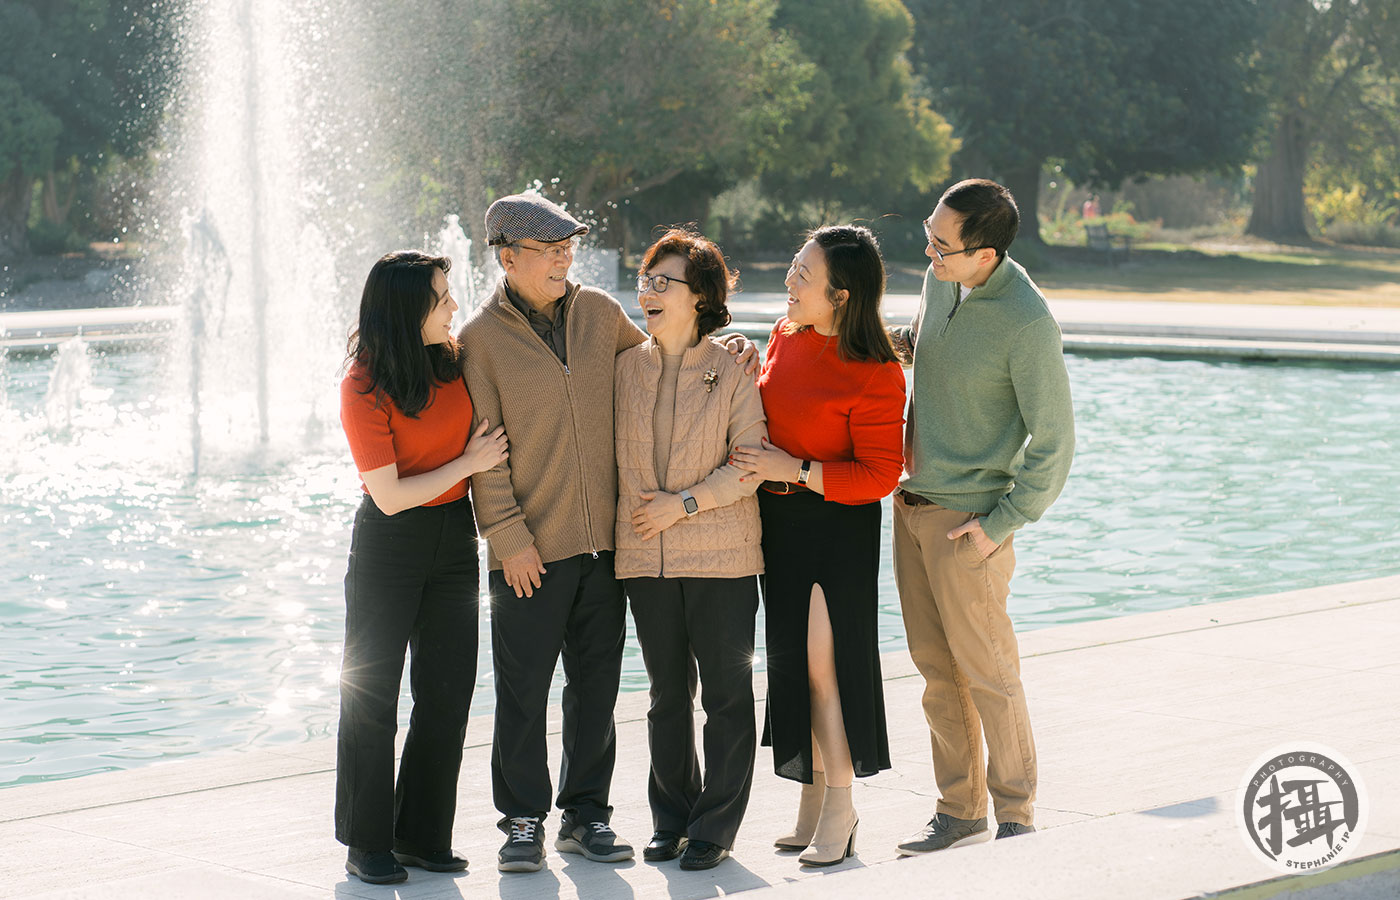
[336,497,480,851]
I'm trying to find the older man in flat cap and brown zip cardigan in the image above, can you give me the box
[459,193,753,872]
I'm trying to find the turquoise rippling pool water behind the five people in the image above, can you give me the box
[0,351,1400,787]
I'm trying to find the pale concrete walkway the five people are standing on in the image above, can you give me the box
[0,577,1400,900]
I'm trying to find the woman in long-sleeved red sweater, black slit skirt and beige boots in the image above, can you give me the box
[735,225,904,865]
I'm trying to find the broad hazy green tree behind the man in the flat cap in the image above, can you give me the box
[366,0,811,250]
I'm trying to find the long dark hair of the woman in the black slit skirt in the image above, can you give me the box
[791,225,897,363]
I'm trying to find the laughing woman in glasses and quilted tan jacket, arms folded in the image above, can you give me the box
[615,230,767,869]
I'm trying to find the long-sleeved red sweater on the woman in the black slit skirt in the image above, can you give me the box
[759,318,904,504]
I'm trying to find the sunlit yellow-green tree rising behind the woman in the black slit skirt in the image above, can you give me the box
[762,0,956,220]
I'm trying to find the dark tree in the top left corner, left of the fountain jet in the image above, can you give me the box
[0,0,178,256]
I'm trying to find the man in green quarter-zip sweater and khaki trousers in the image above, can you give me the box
[892,179,1074,855]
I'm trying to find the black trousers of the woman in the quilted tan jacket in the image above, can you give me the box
[627,575,759,848]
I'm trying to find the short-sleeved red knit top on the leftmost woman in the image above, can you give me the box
[340,365,472,507]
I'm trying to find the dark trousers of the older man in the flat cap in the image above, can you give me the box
[490,551,626,822]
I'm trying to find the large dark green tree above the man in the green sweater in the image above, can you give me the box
[909,0,1261,242]
